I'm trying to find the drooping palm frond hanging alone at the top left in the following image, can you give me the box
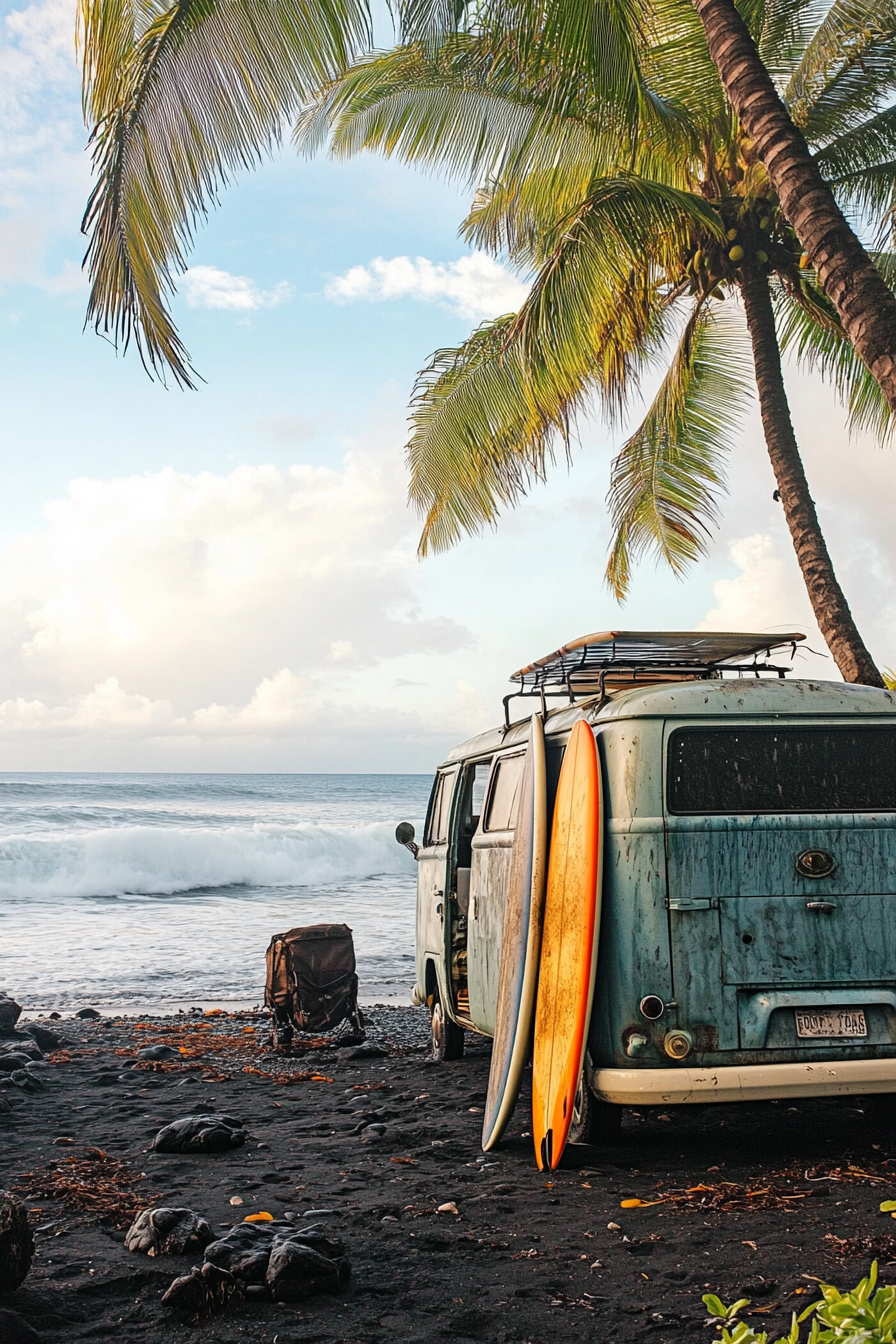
[83,0,369,386]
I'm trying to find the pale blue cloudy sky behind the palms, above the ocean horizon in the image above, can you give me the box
[0,0,896,771]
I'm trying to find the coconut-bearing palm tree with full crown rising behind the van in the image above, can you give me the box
[298,5,896,685]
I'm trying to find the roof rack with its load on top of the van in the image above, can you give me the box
[504,630,806,727]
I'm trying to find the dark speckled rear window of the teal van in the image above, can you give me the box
[666,726,896,816]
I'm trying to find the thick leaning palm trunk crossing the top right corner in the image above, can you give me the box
[692,0,896,411]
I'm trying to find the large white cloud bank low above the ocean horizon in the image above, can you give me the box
[0,452,470,767]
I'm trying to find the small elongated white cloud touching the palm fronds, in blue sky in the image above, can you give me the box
[324,253,528,321]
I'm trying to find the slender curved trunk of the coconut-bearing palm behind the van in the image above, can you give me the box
[740,267,884,687]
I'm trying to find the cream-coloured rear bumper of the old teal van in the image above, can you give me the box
[590,1059,896,1106]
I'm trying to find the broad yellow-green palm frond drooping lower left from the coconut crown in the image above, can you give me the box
[408,179,717,554]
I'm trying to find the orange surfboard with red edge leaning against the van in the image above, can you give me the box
[532,719,603,1171]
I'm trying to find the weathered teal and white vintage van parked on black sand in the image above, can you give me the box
[396,632,896,1141]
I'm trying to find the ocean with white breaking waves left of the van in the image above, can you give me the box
[0,774,431,1013]
